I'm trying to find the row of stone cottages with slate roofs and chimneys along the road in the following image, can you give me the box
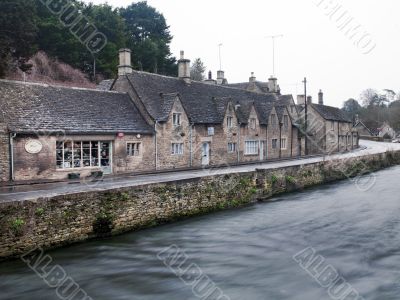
[0,49,358,181]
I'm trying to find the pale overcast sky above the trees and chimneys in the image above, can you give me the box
[83,0,400,106]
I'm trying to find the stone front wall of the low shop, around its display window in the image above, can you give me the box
[14,135,155,181]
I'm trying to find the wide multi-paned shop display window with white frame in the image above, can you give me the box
[56,141,111,169]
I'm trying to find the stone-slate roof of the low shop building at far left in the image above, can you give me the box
[0,80,153,134]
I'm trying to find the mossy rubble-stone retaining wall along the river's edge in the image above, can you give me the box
[0,151,400,259]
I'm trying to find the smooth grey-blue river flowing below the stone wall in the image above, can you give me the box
[0,167,400,300]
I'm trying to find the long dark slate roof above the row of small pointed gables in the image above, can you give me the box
[127,71,279,124]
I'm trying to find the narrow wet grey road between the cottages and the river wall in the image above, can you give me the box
[0,140,400,202]
